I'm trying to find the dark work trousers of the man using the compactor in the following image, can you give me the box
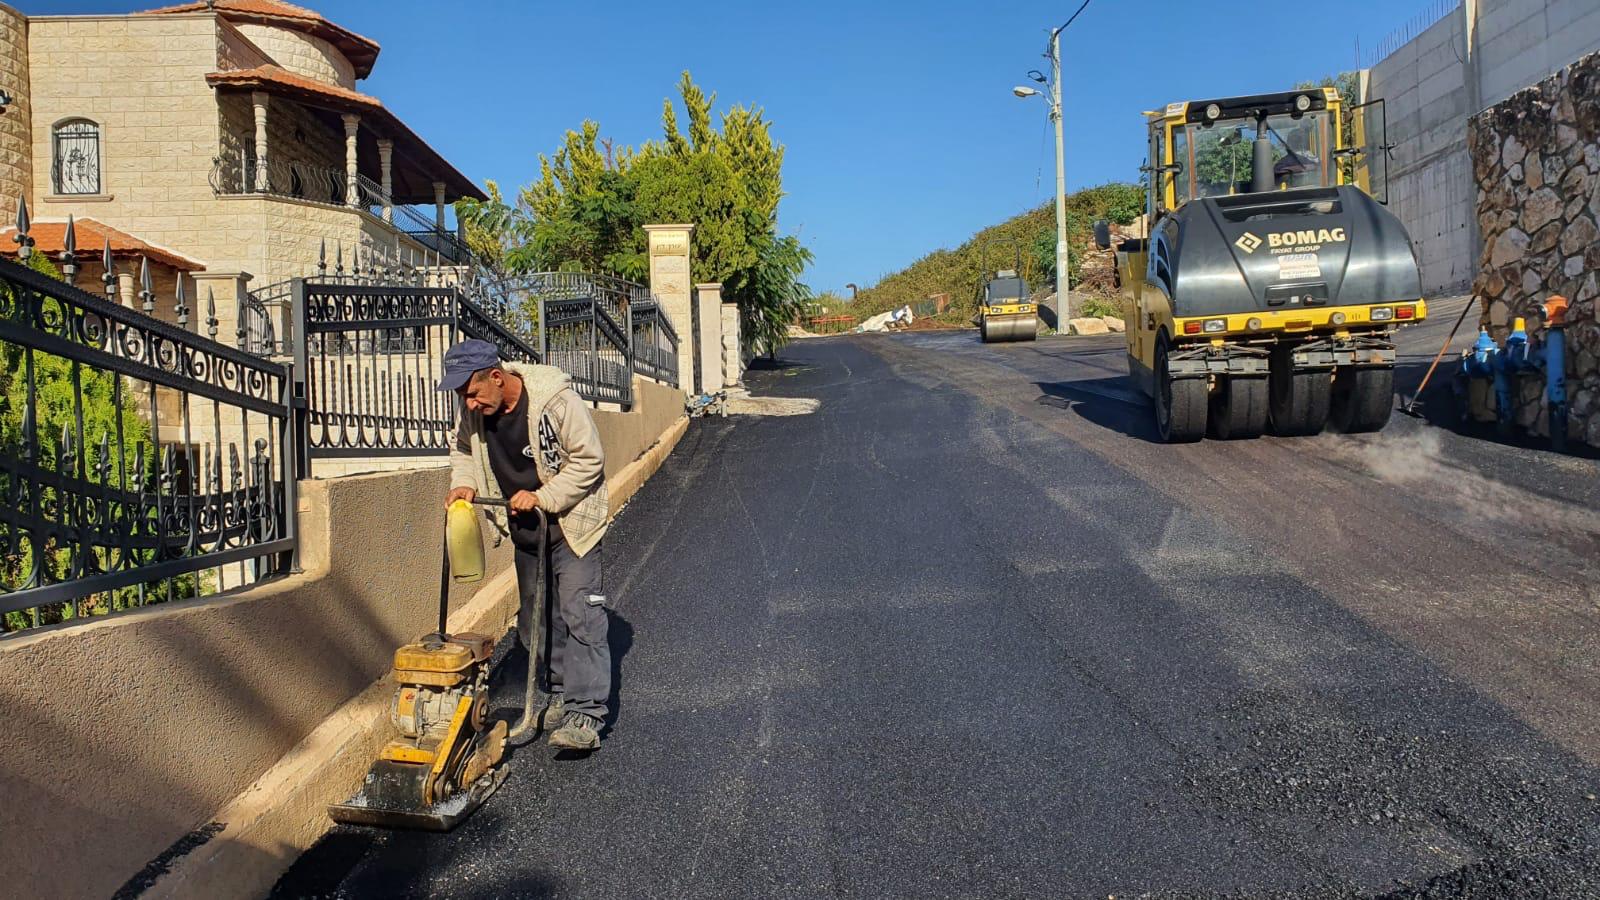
[515,540,611,719]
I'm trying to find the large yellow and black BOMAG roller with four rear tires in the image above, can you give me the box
[1094,88,1427,442]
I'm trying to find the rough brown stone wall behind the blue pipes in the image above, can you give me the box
[1469,53,1600,447]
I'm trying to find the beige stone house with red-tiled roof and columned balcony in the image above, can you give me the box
[0,0,485,338]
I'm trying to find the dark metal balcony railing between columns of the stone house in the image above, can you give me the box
[211,149,472,264]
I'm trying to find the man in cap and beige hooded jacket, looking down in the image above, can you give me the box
[438,340,611,751]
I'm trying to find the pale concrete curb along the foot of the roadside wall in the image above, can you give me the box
[150,416,690,900]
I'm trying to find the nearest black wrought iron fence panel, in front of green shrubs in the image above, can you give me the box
[0,207,296,631]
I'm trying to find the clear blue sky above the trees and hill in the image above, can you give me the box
[34,0,1427,295]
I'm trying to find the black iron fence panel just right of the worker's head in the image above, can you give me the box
[539,298,634,405]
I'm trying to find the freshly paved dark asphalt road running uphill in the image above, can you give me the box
[278,297,1600,898]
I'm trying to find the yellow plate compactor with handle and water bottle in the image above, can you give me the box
[328,500,549,831]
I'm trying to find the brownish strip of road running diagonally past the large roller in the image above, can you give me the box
[867,329,1600,764]
